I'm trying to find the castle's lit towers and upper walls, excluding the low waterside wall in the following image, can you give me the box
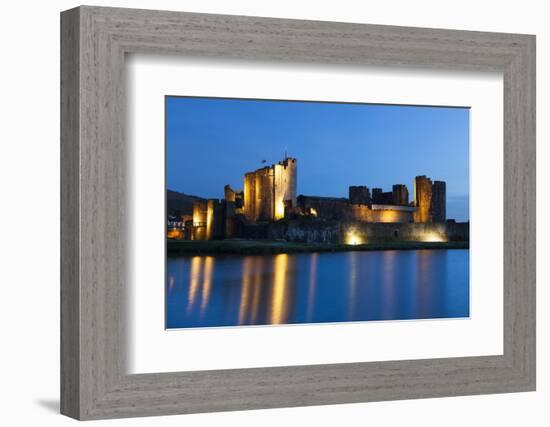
[185,156,446,240]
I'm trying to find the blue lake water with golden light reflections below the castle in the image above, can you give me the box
[166,249,470,329]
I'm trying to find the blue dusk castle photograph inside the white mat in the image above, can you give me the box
[165,96,470,329]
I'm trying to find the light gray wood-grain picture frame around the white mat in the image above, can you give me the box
[61,6,535,419]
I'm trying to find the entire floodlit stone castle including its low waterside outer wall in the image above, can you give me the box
[185,157,452,244]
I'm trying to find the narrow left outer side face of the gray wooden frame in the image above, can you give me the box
[60,10,80,417]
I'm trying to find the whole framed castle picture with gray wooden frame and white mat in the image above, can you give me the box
[61,6,536,420]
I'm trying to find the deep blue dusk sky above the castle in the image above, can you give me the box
[166,96,469,221]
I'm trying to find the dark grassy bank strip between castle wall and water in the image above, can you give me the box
[166,239,470,256]
